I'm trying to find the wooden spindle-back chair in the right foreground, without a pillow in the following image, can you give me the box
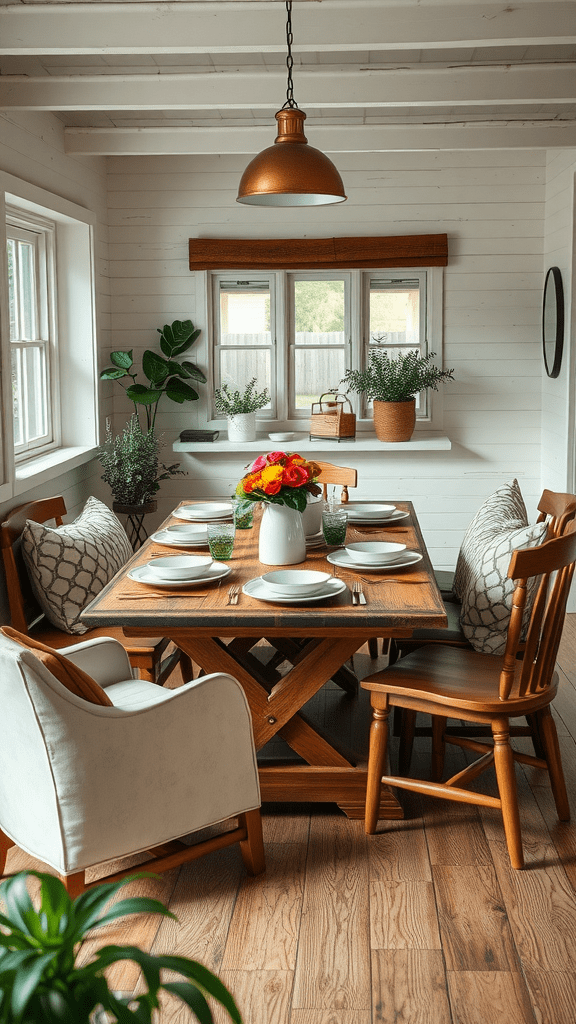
[362,522,576,868]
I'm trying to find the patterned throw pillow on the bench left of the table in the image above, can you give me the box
[22,498,132,634]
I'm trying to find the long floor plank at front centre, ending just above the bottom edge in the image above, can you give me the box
[292,816,370,1010]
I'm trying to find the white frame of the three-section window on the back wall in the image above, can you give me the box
[203,266,444,433]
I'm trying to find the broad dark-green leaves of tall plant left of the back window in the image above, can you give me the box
[100,321,206,430]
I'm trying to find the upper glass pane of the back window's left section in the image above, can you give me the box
[220,281,272,345]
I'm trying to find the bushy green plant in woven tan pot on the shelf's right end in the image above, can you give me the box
[340,349,454,441]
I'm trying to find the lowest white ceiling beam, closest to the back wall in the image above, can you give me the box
[65,122,576,157]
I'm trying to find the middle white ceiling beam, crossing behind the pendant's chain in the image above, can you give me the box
[0,65,576,111]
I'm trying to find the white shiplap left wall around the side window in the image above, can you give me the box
[0,114,112,622]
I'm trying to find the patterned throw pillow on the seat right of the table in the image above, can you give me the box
[454,480,546,654]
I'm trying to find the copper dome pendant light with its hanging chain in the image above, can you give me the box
[236,0,346,206]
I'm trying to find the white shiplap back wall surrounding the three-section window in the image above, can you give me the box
[109,151,548,567]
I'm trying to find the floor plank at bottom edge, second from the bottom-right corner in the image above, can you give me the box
[372,949,450,1024]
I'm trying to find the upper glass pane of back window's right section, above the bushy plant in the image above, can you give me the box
[370,281,420,348]
